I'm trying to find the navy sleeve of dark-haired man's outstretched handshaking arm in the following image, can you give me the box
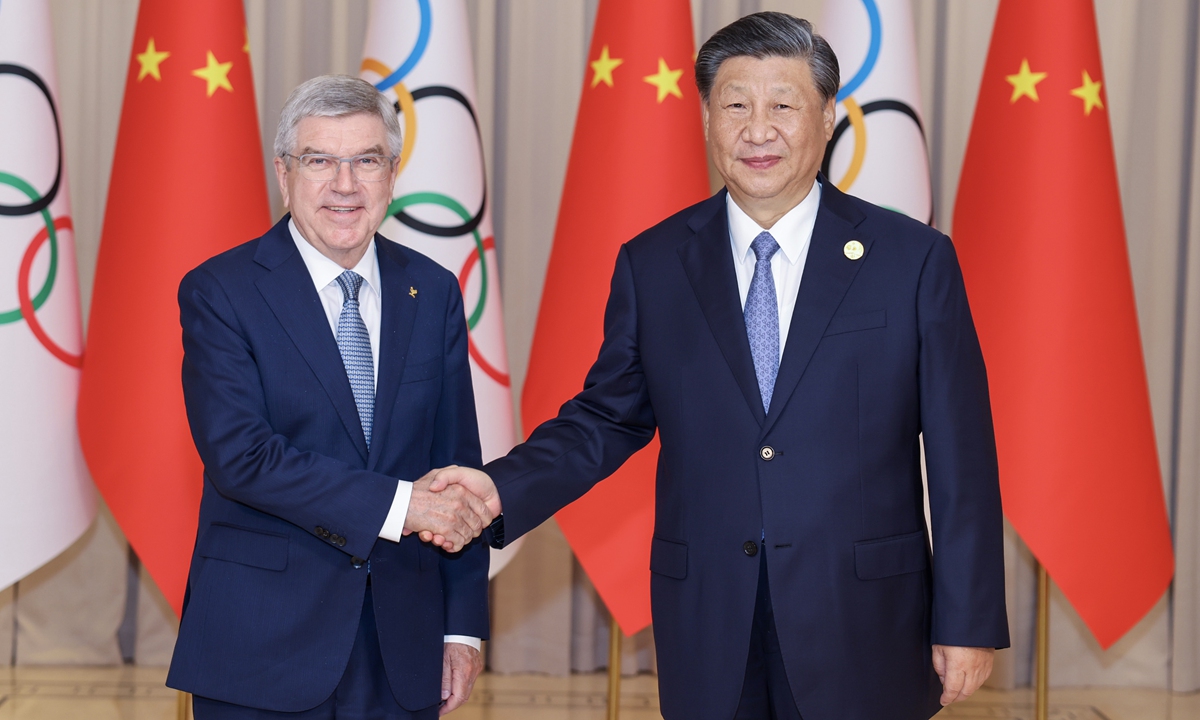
[484,246,656,542]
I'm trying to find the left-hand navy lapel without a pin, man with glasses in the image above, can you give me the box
[254,216,367,461]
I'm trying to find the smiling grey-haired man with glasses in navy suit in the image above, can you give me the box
[167,76,492,720]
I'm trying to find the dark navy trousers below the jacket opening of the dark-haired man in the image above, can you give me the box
[733,552,802,720]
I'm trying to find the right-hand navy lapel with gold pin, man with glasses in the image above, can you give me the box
[367,235,420,470]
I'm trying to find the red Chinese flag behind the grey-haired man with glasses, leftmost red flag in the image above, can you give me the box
[79,0,270,613]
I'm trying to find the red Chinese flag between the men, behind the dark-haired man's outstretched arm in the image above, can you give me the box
[521,0,708,635]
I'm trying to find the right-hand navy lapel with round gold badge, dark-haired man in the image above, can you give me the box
[762,182,871,434]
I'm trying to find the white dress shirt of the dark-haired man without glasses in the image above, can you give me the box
[725,180,821,359]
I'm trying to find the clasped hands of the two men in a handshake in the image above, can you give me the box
[404,470,496,552]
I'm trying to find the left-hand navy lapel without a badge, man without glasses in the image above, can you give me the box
[679,191,763,425]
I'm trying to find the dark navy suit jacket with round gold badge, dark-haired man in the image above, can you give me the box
[485,182,1008,720]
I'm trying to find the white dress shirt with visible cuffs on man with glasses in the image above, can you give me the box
[288,220,481,650]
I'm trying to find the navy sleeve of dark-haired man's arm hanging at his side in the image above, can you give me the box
[917,235,1008,648]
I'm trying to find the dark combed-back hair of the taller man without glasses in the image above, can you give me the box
[696,12,840,103]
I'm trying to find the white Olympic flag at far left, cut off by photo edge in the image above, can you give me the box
[0,0,96,588]
